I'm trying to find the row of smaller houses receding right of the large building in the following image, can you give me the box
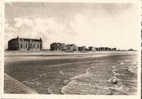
[50,42,117,51]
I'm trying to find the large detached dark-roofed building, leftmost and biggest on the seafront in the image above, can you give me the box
[8,37,42,51]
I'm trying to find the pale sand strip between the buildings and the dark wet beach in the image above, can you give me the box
[4,51,138,63]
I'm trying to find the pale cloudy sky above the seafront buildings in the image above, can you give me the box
[5,2,139,49]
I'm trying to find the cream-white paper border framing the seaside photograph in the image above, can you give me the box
[0,0,141,99]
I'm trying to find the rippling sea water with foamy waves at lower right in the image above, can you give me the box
[62,55,137,95]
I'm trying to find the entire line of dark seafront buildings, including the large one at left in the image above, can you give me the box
[8,37,117,52]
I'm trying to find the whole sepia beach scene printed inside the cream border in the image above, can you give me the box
[4,2,140,95]
